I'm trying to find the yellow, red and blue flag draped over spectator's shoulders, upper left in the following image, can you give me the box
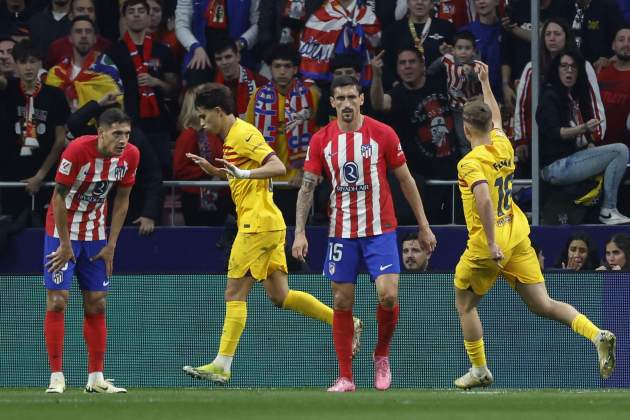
[46,51,122,111]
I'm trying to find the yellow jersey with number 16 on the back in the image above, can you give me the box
[457,129,529,259]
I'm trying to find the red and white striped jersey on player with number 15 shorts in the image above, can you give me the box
[304,116,406,238]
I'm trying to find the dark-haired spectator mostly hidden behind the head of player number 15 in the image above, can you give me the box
[317,53,374,127]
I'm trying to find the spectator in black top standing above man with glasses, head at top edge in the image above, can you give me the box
[383,0,455,87]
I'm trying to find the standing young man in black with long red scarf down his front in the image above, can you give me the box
[107,0,178,178]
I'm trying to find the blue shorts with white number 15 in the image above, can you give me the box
[322,232,400,283]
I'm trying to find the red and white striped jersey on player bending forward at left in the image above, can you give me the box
[46,136,140,241]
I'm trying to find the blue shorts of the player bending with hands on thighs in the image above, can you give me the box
[44,235,109,292]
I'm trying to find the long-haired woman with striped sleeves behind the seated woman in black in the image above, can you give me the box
[514,18,606,172]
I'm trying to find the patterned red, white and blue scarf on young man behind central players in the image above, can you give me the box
[254,79,315,168]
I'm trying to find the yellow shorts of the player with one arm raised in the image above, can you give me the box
[455,238,545,296]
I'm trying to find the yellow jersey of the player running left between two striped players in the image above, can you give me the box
[223,118,286,233]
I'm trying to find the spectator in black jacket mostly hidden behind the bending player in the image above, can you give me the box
[67,93,162,235]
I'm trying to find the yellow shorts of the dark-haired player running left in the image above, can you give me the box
[228,230,289,281]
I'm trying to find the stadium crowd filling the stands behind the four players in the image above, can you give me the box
[0,0,630,230]
